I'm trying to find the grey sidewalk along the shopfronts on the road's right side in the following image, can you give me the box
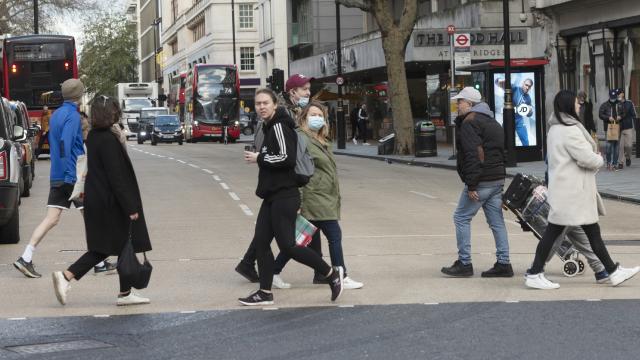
[333,141,640,204]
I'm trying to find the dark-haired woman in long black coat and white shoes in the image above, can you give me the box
[52,96,151,305]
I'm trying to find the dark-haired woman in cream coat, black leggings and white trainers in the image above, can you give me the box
[525,90,640,290]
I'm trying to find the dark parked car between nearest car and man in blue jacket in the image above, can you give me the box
[10,101,38,197]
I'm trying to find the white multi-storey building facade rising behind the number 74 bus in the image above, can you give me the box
[162,0,260,107]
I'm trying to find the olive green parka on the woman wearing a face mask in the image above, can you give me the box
[301,131,340,220]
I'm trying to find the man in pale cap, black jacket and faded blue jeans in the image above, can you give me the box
[442,87,513,277]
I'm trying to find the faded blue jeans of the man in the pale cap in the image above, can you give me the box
[453,180,509,265]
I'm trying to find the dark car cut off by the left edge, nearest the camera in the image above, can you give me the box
[0,98,26,244]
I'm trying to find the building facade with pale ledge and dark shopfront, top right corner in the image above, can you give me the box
[531,0,640,136]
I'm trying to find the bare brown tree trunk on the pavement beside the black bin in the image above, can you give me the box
[382,33,414,155]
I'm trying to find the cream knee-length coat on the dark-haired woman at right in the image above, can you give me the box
[547,114,605,226]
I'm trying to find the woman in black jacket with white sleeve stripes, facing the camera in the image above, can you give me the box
[238,89,344,305]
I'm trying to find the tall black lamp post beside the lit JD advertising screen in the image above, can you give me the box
[502,0,517,167]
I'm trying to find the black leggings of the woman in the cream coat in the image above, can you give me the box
[529,223,617,274]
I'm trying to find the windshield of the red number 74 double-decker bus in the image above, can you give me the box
[193,66,238,124]
